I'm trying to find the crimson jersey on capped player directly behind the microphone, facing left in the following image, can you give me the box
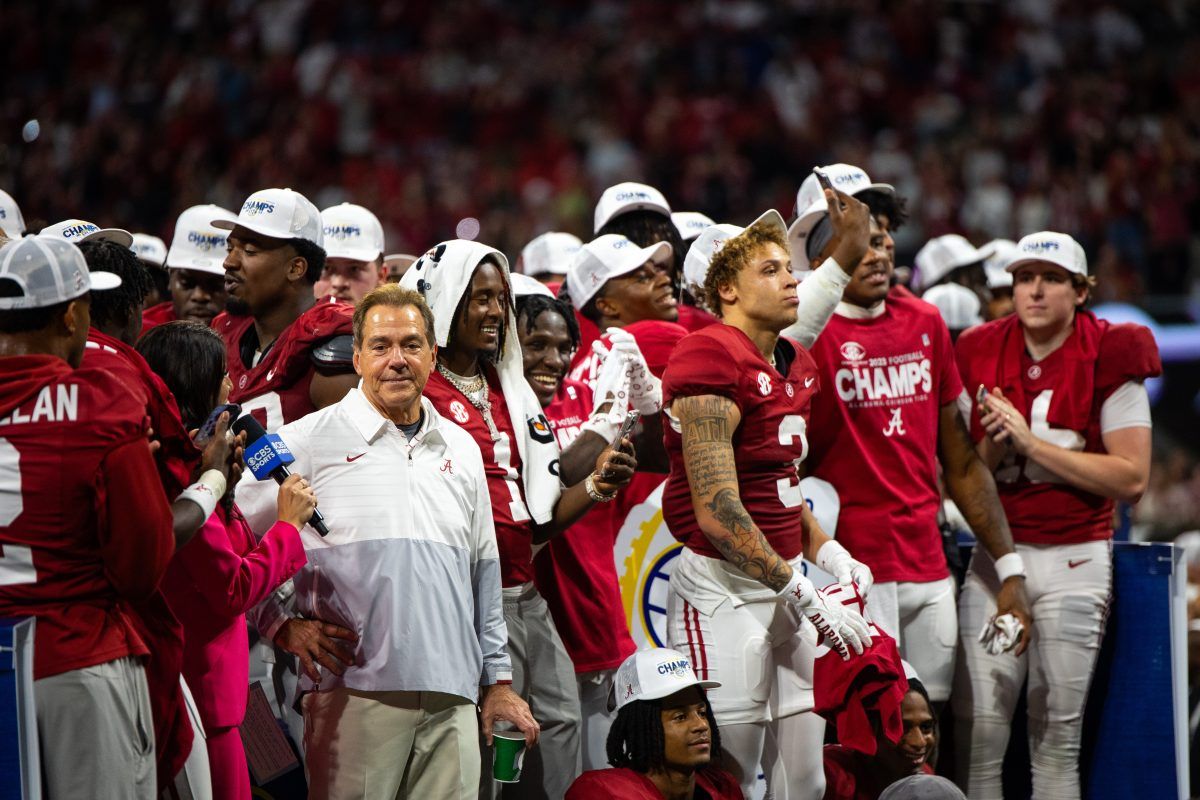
[212,301,354,431]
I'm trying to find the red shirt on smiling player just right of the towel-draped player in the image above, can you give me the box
[534,380,637,673]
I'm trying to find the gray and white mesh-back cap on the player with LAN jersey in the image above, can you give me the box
[0,235,121,311]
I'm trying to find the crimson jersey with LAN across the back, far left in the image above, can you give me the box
[0,355,175,679]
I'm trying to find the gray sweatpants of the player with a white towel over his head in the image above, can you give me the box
[480,583,582,800]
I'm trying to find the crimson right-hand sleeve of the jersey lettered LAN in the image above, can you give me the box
[98,438,175,600]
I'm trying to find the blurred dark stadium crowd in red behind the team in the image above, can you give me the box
[7,0,1200,539]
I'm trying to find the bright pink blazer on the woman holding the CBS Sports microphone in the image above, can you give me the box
[161,506,307,728]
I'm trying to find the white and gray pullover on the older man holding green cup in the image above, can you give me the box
[238,389,512,702]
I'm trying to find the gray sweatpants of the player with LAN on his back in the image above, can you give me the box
[34,657,155,800]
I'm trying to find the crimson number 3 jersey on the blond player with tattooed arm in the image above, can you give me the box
[662,325,821,560]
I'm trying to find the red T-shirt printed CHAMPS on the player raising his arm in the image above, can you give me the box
[809,297,962,583]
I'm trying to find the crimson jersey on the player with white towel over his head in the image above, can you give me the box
[425,367,533,588]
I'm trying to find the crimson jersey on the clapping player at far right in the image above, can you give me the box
[956,312,1162,545]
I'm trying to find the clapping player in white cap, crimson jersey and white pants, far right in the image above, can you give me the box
[953,231,1162,800]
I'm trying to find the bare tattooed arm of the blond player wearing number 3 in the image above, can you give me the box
[671,395,792,591]
